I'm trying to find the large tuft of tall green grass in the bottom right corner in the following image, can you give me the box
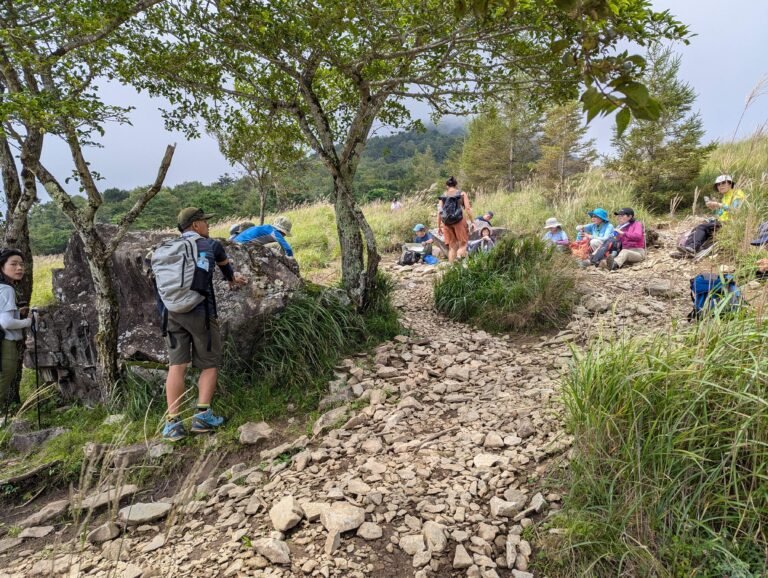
[545,315,768,578]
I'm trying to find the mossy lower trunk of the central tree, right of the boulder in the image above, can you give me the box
[333,173,380,311]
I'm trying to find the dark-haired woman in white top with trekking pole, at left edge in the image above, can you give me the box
[0,248,32,413]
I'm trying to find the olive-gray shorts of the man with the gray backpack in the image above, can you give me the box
[165,311,221,369]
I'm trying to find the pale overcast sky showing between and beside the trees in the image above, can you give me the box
[41,0,768,195]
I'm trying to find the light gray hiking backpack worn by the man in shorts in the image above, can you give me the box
[151,235,208,313]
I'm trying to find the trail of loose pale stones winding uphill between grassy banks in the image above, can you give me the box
[0,218,744,578]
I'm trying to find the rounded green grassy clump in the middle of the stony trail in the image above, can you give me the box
[434,237,575,331]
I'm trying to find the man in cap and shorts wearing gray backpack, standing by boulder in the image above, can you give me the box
[151,207,246,441]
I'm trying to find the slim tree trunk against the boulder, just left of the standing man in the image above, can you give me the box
[80,228,122,402]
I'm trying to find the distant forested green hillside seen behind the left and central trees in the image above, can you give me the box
[29,127,463,255]
